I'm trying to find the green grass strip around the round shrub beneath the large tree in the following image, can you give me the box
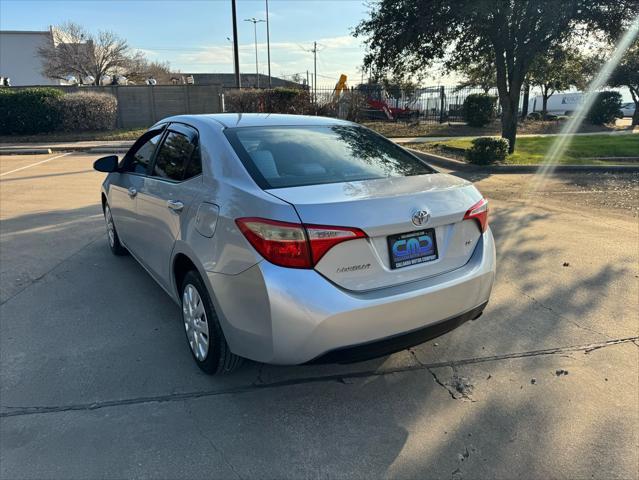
[409,134,639,165]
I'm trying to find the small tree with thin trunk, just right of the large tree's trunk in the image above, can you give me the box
[528,45,584,115]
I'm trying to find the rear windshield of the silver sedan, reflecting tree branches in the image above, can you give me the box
[224,125,434,188]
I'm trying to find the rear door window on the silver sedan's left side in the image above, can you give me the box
[153,131,202,181]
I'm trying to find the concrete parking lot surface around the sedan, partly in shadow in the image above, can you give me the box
[0,153,639,480]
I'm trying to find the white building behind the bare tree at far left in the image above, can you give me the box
[0,29,65,87]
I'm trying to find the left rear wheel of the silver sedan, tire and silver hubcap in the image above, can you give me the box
[180,270,243,375]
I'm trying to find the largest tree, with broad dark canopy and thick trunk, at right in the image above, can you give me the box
[354,0,639,152]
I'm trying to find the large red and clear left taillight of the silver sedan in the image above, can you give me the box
[235,217,366,268]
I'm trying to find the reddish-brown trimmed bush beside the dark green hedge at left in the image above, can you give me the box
[57,92,118,132]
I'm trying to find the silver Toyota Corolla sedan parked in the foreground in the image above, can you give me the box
[94,114,495,373]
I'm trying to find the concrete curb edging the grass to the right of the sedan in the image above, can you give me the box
[404,147,639,174]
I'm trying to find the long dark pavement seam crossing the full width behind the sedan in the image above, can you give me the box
[0,336,639,418]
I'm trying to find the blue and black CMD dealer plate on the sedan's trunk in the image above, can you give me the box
[387,228,437,269]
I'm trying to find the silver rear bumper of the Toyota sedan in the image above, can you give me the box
[208,230,495,364]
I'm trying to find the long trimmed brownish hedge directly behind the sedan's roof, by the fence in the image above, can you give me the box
[224,87,311,114]
